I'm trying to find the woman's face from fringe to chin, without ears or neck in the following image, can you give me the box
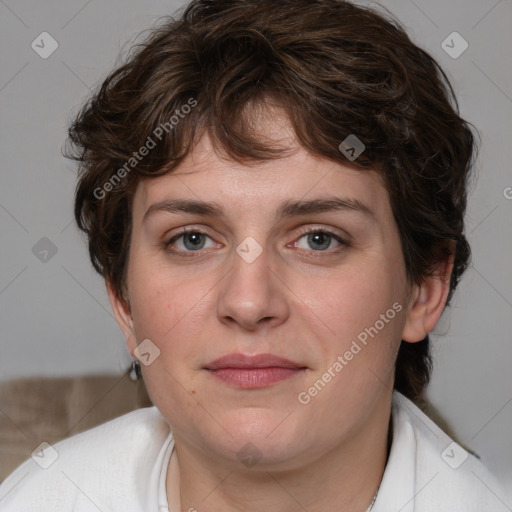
[111,107,424,467]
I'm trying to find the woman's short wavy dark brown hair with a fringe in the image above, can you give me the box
[68,0,474,400]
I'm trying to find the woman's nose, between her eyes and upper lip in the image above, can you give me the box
[217,243,289,331]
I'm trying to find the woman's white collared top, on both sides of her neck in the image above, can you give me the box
[0,392,512,512]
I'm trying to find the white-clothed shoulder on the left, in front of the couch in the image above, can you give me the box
[0,407,172,512]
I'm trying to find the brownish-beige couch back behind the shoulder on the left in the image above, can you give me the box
[0,374,151,482]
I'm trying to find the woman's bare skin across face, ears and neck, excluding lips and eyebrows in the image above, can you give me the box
[107,107,452,512]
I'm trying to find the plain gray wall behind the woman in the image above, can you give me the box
[0,0,512,488]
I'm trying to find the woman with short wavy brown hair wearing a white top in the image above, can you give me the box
[0,0,510,512]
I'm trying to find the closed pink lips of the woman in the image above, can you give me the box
[204,353,307,389]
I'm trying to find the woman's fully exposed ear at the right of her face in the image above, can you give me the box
[402,245,454,343]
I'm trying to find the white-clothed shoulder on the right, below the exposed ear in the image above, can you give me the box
[374,392,510,512]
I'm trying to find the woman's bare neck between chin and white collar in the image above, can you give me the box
[167,400,391,512]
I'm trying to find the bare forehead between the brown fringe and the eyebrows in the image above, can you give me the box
[133,107,389,219]
